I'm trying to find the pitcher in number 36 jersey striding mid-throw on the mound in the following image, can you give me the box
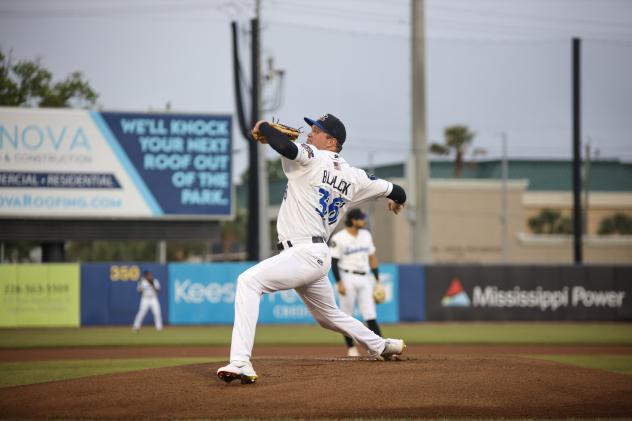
[217,114,406,383]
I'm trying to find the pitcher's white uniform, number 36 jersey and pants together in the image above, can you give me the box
[230,144,393,361]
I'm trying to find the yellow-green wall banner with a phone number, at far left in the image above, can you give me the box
[0,264,79,327]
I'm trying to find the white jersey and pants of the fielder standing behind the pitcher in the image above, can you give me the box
[331,229,377,320]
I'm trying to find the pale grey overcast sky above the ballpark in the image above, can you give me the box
[0,0,632,179]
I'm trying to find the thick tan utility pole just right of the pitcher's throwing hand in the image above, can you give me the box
[409,0,431,263]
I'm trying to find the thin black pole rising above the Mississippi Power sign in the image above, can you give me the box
[572,38,583,264]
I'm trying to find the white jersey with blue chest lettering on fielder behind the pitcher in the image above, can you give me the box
[331,229,375,273]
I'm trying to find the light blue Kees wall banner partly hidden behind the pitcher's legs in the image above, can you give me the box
[169,263,399,324]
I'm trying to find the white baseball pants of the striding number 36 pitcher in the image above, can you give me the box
[230,243,384,361]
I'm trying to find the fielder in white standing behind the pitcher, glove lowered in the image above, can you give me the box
[331,208,382,357]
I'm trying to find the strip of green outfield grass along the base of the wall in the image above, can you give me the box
[0,322,632,348]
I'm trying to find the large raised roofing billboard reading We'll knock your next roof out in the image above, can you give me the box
[0,107,233,218]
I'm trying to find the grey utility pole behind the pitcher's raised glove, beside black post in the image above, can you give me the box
[251,0,270,260]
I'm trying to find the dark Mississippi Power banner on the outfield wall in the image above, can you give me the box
[426,265,632,321]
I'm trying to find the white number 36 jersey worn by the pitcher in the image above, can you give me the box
[277,143,393,241]
